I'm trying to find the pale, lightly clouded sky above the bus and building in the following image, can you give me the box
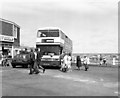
[0,0,118,53]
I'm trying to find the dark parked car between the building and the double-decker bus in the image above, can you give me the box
[11,53,29,68]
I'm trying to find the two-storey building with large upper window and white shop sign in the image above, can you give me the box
[0,18,20,57]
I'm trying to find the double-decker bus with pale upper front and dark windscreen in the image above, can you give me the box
[36,27,72,67]
